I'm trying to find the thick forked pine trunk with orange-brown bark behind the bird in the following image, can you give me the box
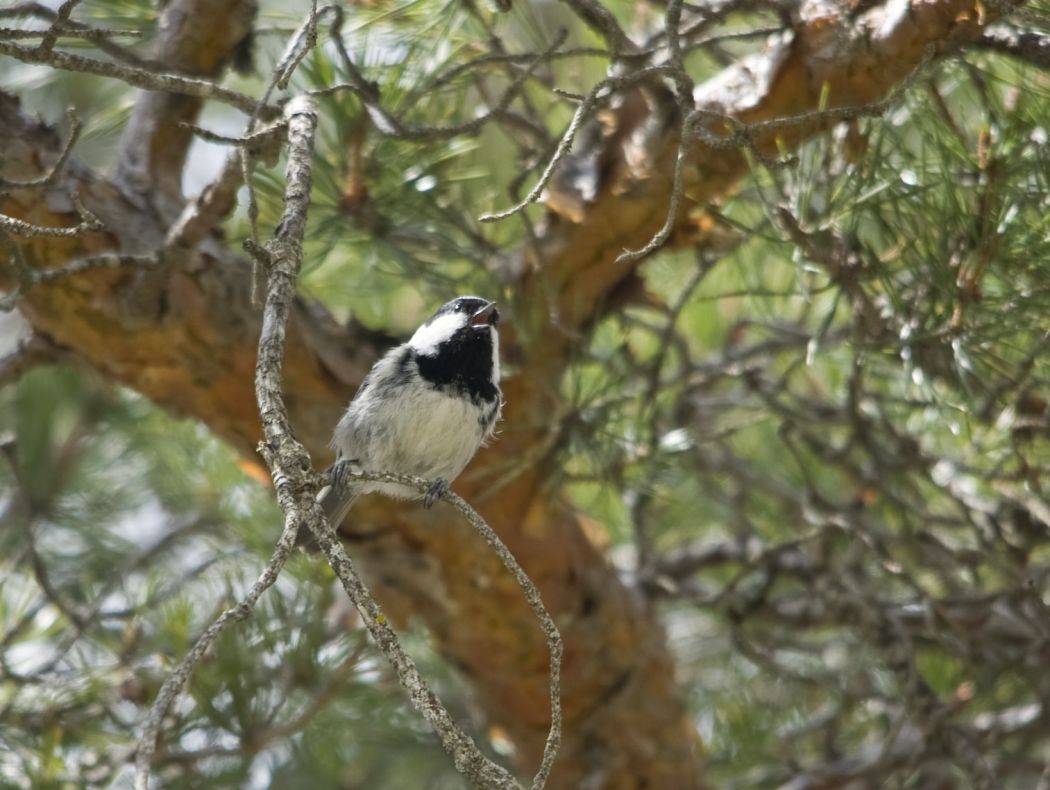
[0,0,987,789]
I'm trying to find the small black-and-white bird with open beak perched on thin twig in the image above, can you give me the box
[317,296,503,527]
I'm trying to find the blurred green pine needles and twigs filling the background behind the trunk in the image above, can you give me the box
[0,0,1050,788]
